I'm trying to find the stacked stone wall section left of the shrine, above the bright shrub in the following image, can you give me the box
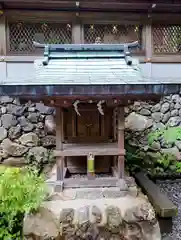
[0,96,55,166]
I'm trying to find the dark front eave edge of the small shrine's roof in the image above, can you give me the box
[0,83,181,100]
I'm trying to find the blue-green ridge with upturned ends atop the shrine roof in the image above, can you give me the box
[34,41,138,65]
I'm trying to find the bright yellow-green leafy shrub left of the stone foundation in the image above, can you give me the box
[0,166,46,240]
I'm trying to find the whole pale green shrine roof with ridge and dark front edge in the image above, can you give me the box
[0,42,181,99]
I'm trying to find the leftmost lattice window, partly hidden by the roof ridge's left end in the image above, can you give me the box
[7,22,72,54]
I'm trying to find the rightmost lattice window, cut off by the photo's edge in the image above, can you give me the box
[152,25,181,54]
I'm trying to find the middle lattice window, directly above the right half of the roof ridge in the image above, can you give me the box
[84,24,142,50]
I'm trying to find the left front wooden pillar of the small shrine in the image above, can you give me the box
[56,107,64,190]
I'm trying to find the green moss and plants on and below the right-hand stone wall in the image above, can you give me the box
[126,127,181,177]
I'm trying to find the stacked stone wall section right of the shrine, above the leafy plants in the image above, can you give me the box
[125,94,181,155]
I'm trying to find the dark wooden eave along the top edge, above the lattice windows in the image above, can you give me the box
[0,0,181,13]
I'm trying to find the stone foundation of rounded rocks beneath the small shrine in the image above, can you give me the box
[24,178,161,240]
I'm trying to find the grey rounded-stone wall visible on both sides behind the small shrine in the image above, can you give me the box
[0,95,181,166]
